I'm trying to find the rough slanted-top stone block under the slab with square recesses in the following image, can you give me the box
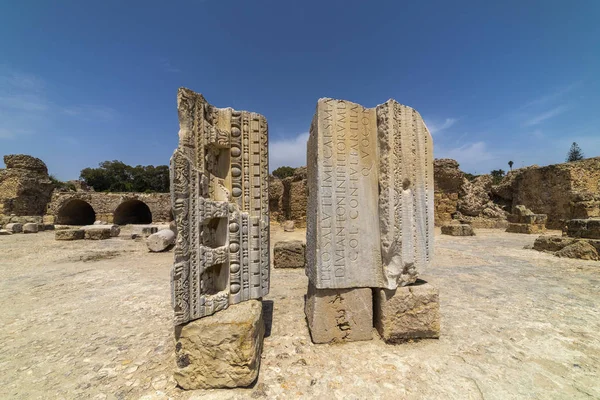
[174,300,265,389]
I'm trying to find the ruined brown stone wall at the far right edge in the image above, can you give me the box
[494,157,600,229]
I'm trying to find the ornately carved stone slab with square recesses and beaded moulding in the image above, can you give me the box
[171,88,269,325]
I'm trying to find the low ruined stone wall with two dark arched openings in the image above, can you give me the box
[47,192,172,223]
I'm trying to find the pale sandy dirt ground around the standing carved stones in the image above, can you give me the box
[0,226,600,399]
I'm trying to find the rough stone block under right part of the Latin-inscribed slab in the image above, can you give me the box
[373,281,440,343]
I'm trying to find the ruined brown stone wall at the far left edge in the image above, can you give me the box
[0,154,54,216]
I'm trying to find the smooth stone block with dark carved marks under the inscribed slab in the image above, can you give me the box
[304,282,373,343]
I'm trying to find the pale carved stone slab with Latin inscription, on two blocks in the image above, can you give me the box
[306,99,434,289]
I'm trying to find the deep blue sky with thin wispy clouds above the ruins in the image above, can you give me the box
[0,0,600,180]
